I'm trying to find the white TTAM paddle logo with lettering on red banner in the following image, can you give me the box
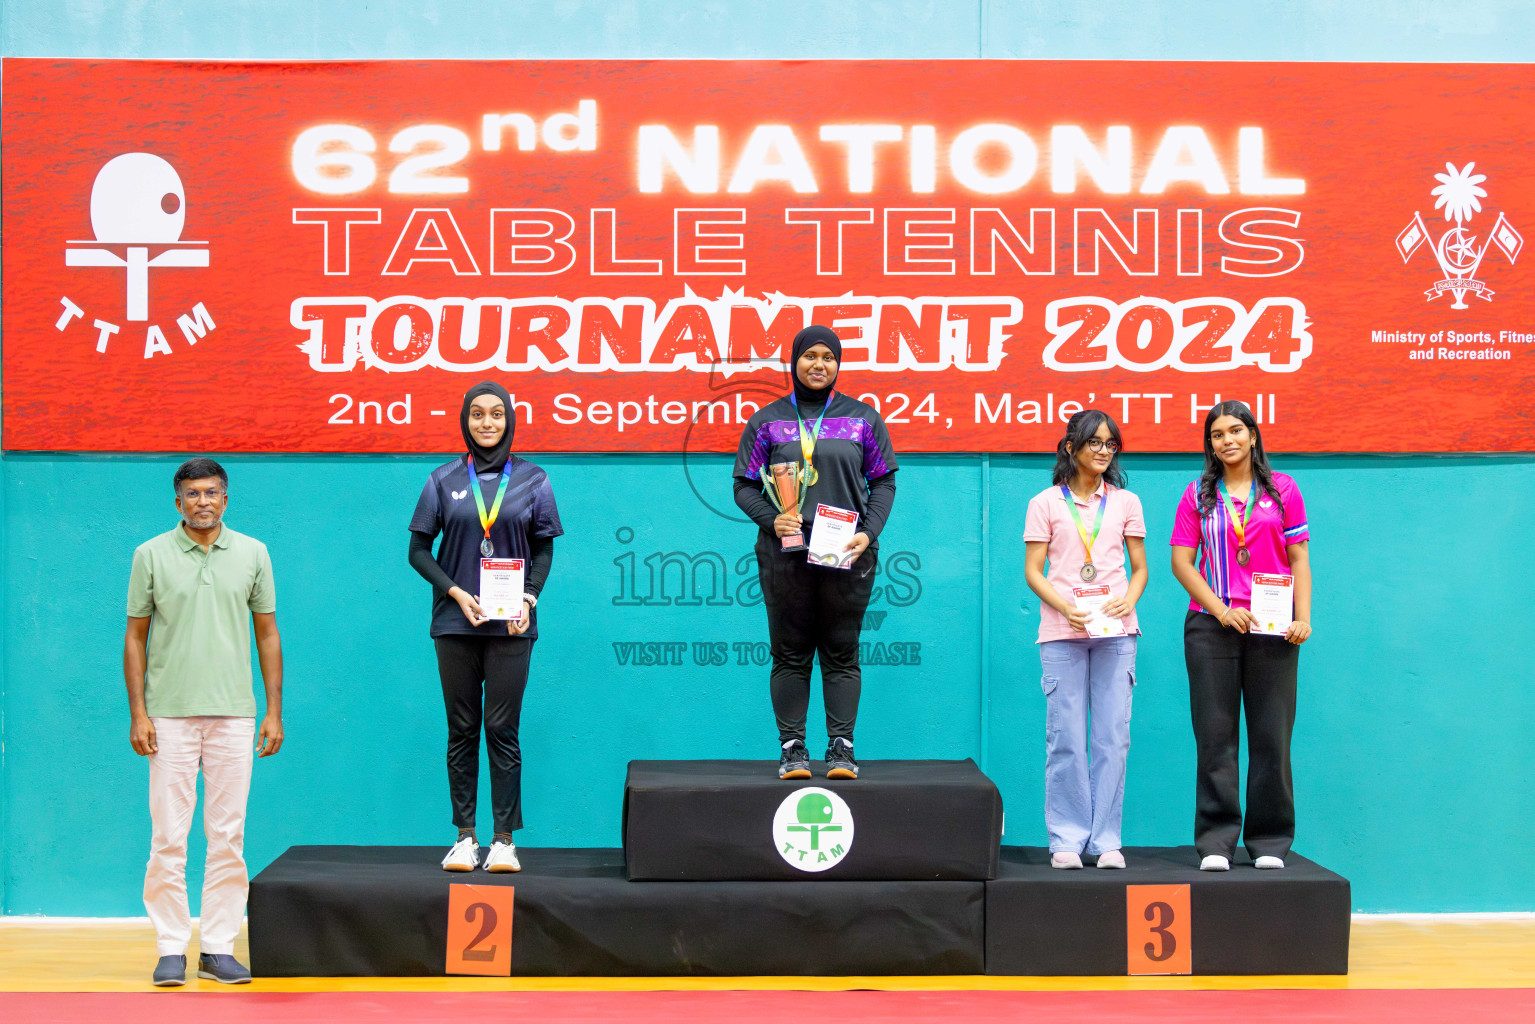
[55,152,215,359]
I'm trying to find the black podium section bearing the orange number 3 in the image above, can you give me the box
[985,846,1349,975]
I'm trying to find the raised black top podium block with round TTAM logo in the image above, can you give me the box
[623,758,1002,883]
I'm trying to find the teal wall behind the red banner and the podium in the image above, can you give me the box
[0,0,1535,915]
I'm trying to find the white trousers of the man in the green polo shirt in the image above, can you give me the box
[144,717,256,956]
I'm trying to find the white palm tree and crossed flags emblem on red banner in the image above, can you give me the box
[1397,163,1524,309]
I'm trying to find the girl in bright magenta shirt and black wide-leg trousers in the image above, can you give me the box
[1173,402,1311,870]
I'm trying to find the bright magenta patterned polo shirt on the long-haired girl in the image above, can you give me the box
[1171,473,1311,611]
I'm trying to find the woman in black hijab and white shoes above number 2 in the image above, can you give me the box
[410,381,565,872]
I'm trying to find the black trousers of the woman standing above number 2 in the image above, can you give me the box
[436,636,533,832]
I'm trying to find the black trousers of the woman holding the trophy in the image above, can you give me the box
[757,533,880,743]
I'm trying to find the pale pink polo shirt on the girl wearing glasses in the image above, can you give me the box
[1024,482,1147,643]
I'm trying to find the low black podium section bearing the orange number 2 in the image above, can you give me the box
[249,846,985,978]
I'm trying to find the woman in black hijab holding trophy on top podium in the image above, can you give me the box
[735,325,896,778]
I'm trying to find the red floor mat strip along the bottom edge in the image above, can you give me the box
[11,989,1535,1024]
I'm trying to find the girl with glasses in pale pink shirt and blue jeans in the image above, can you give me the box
[1024,408,1147,867]
